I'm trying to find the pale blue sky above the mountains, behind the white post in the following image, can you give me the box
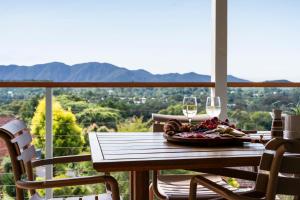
[0,0,300,81]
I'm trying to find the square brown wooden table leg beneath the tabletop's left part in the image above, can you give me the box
[132,171,149,200]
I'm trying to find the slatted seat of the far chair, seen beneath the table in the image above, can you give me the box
[158,174,251,200]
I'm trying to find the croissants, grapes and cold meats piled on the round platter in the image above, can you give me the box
[164,117,246,139]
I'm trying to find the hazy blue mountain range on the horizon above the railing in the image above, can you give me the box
[0,62,248,82]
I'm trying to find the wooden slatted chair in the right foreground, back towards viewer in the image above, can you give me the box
[190,138,300,200]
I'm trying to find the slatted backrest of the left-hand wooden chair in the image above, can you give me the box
[0,120,36,197]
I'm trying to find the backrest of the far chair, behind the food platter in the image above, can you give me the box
[152,113,209,132]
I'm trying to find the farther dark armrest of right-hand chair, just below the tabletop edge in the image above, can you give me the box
[191,168,257,181]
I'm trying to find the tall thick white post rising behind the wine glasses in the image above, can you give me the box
[211,0,227,119]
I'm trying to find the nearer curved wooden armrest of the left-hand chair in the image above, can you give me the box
[16,176,120,200]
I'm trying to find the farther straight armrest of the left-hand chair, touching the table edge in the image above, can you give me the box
[32,155,91,167]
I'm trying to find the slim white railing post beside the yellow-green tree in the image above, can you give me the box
[46,88,53,199]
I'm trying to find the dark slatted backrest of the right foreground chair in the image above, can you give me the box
[255,138,300,199]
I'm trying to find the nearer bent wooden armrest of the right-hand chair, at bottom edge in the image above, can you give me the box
[189,175,255,200]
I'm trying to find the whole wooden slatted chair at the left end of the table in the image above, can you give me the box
[0,120,120,200]
